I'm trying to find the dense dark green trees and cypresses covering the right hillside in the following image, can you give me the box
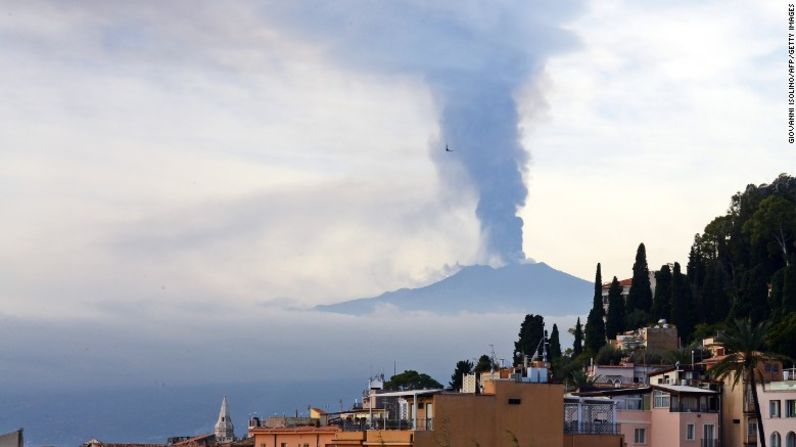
[585,174,796,357]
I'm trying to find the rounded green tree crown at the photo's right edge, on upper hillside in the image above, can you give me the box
[743,195,796,265]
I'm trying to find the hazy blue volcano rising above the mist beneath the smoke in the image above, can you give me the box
[316,262,594,315]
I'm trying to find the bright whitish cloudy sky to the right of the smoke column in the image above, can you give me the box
[520,1,796,277]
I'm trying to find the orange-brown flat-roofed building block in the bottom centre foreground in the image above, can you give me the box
[249,362,622,447]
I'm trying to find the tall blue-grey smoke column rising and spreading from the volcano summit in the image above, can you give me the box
[264,0,579,262]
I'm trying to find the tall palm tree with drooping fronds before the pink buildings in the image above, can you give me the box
[711,318,780,447]
